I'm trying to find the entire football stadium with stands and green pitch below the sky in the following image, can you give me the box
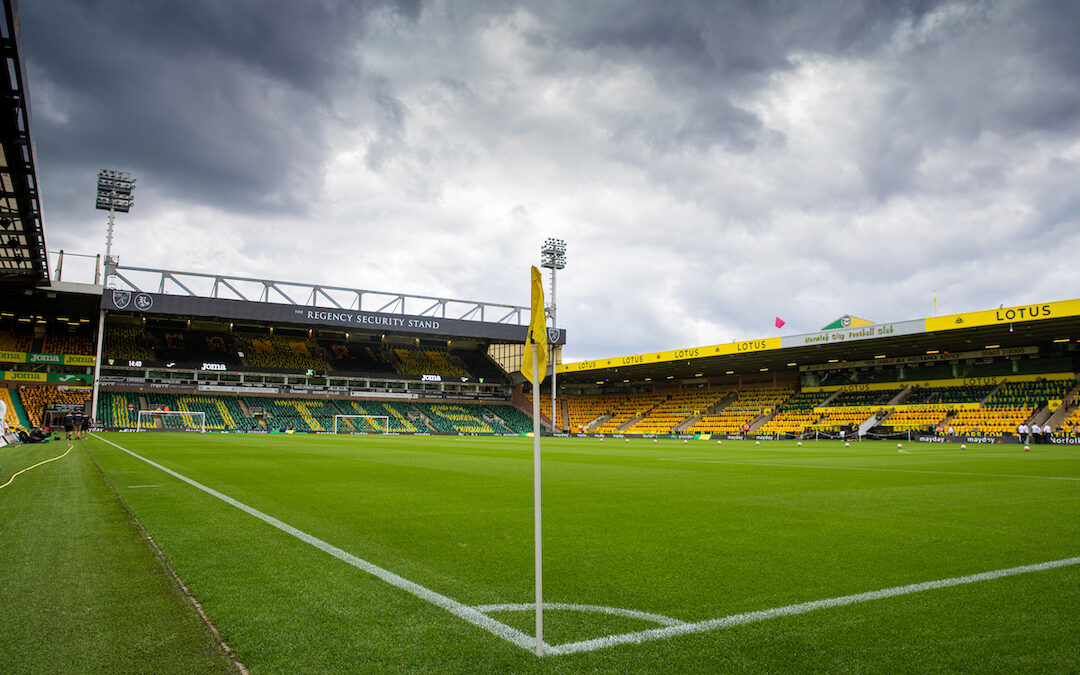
[0,2,1080,673]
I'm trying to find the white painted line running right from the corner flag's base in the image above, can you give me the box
[551,557,1080,654]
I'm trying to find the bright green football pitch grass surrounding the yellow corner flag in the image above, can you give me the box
[6,434,1080,673]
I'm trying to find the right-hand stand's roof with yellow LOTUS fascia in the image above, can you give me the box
[558,299,1080,384]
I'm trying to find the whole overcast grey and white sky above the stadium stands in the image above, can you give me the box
[19,0,1080,361]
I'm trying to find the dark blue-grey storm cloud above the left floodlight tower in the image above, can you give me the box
[21,0,419,212]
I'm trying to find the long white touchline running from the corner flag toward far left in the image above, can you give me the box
[91,434,552,652]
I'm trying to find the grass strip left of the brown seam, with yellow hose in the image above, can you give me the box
[0,441,234,673]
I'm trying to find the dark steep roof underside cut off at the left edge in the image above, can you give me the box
[0,0,49,285]
